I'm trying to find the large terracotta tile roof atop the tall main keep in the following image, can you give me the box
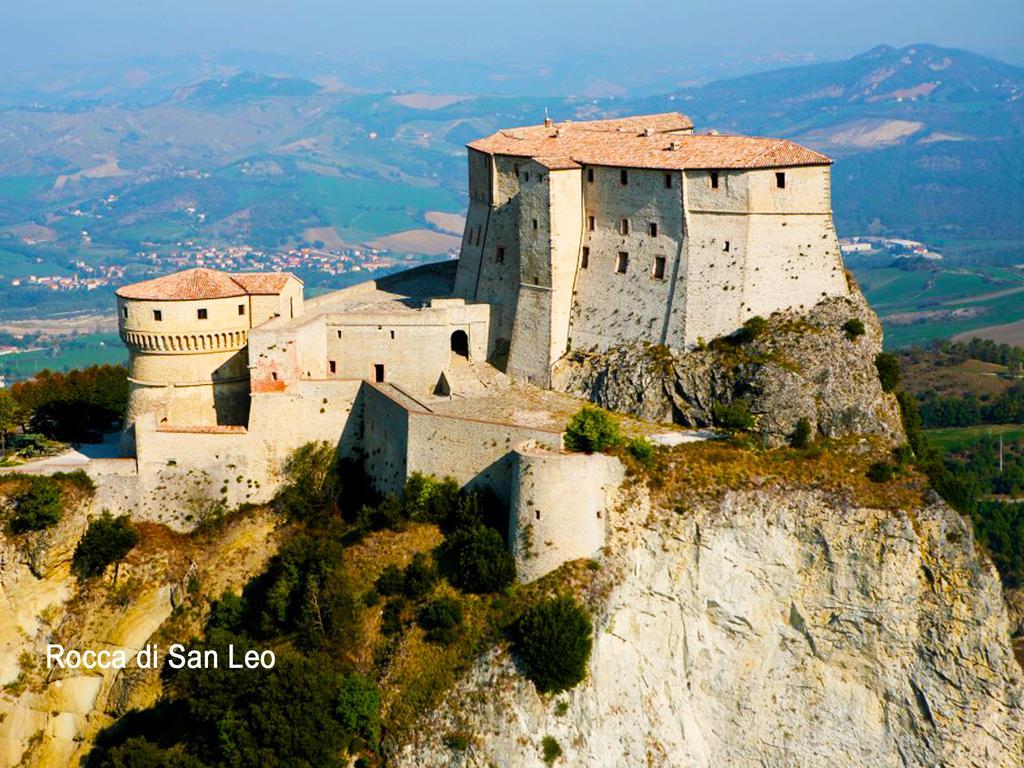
[469,113,831,170]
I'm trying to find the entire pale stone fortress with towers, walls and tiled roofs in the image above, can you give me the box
[97,114,849,581]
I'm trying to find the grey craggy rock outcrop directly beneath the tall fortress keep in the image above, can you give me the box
[552,290,901,445]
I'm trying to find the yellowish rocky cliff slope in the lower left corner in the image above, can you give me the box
[0,499,276,768]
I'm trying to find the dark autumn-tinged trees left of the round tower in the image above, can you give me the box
[0,366,128,442]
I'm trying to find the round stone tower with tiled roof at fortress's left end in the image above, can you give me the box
[117,269,252,442]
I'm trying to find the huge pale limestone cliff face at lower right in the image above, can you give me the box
[395,490,1024,768]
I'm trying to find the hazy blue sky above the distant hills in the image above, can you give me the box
[0,0,1024,71]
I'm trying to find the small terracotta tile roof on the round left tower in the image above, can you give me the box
[117,267,294,301]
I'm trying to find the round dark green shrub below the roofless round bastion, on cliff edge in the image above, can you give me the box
[515,597,593,693]
